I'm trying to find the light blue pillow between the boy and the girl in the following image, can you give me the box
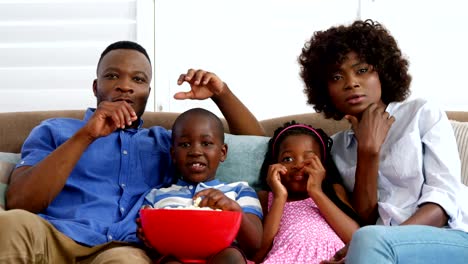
[216,134,270,190]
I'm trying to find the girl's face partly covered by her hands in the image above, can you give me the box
[278,134,322,195]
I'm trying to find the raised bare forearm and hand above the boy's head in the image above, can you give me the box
[174,69,265,136]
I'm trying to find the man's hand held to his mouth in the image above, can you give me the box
[85,101,138,140]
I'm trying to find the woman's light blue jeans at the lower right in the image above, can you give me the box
[346,225,468,264]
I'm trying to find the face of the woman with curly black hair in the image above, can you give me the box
[328,52,384,118]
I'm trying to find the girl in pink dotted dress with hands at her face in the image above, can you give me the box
[255,121,359,264]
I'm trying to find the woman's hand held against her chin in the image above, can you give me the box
[345,104,395,154]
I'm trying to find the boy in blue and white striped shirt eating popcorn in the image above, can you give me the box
[145,108,263,263]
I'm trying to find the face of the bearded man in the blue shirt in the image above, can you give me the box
[93,49,152,117]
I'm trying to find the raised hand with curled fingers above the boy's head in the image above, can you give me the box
[174,69,226,100]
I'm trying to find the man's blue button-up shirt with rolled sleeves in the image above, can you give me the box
[17,109,173,246]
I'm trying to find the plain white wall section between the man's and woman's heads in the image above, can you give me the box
[155,0,358,119]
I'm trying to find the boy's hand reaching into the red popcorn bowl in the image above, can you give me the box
[193,189,242,212]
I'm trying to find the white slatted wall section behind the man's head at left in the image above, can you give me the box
[0,0,154,112]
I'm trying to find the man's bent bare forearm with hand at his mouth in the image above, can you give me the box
[6,102,137,213]
